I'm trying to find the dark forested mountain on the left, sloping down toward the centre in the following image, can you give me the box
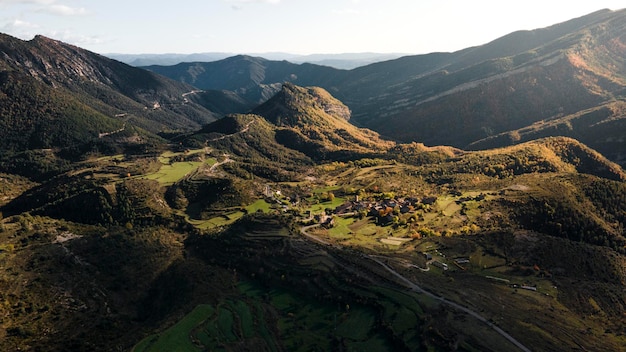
[0,35,251,178]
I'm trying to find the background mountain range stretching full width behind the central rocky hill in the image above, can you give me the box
[3,10,626,168]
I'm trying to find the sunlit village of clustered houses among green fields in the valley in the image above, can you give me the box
[265,186,548,298]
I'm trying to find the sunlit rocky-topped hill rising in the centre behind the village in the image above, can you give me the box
[184,83,395,177]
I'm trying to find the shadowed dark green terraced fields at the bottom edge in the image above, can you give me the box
[132,282,400,352]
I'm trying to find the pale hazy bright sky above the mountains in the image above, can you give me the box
[0,0,626,54]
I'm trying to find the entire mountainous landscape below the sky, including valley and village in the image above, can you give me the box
[0,10,626,352]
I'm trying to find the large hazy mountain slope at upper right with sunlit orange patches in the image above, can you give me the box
[352,10,626,148]
